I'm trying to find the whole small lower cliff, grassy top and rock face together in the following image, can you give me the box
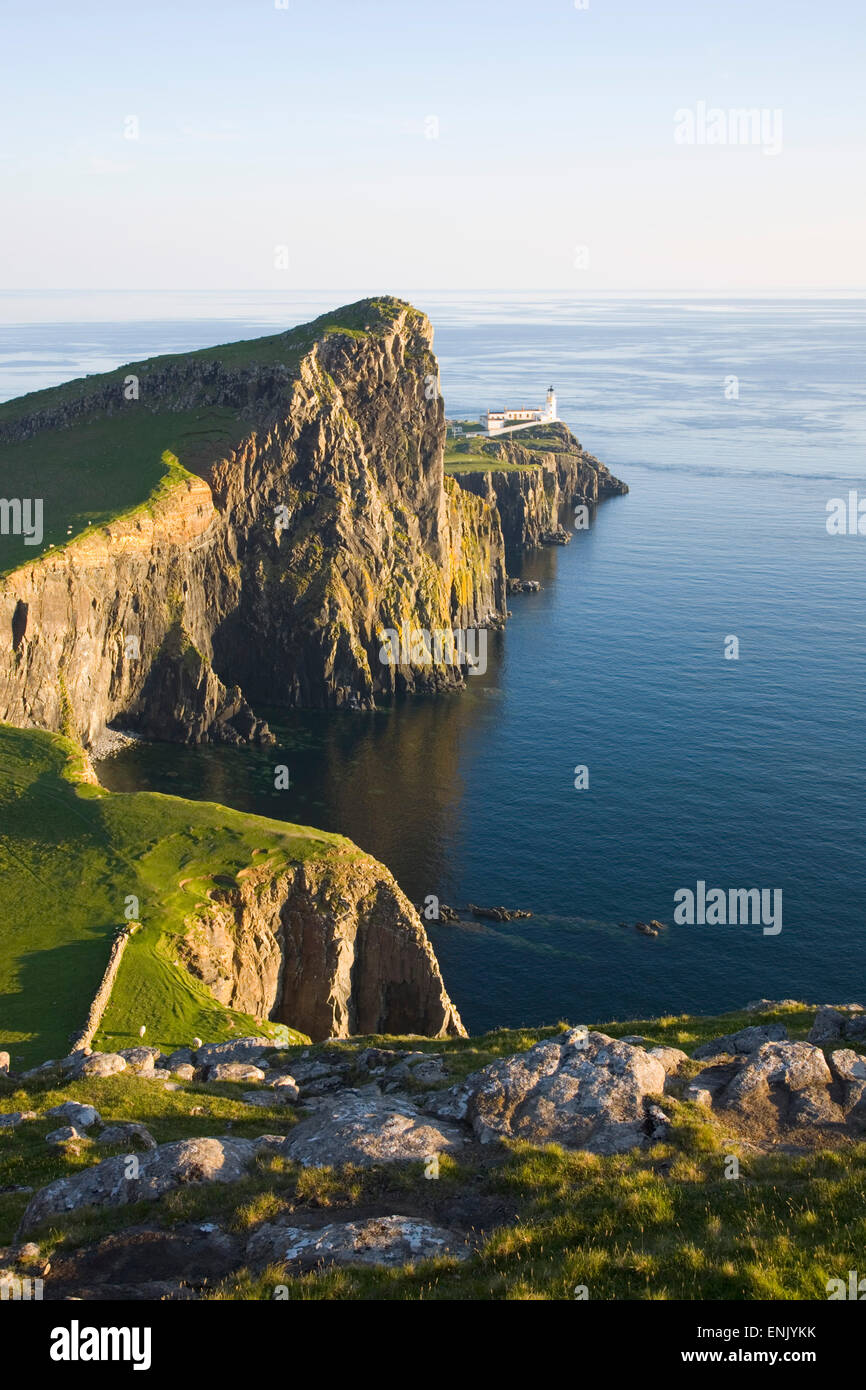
[0,724,463,1062]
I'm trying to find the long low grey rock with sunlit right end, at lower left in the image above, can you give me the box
[21,1138,256,1233]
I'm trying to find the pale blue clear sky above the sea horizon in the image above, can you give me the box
[0,0,866,293]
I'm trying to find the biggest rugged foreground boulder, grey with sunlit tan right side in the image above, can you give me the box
[444,1029,664,1154]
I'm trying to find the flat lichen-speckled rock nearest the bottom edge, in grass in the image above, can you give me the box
[246,1216,470,1273]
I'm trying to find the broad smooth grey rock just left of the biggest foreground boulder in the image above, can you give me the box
[282,1087,463,1168]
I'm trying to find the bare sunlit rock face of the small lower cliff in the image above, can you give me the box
[177,848,464,1061]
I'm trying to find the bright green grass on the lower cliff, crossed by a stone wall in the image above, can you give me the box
[0,726,372,1068]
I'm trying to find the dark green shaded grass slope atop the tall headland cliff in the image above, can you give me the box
[0,300,399,575]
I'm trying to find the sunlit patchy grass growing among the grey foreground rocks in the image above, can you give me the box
[0,1006,866,1300]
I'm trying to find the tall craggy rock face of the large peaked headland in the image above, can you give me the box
[0,300,505,745]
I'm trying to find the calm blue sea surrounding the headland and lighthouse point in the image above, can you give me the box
[0,292,866,1030]
